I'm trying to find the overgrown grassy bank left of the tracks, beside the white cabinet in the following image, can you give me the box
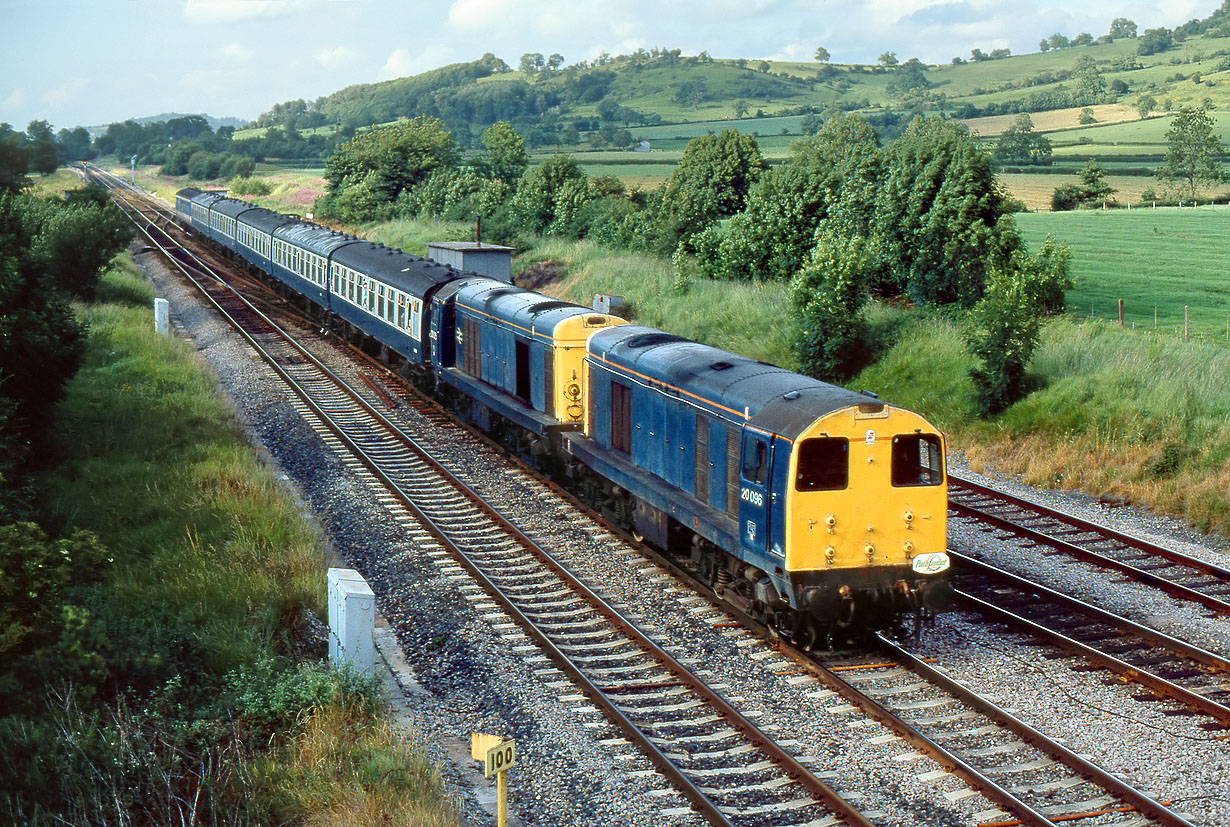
[10,256,456,825]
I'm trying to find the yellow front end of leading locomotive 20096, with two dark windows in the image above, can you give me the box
[785,400,951,625]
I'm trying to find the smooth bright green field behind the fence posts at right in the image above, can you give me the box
[1017,207,1230,341]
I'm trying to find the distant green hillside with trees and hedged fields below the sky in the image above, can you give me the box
[236,7,1230,162]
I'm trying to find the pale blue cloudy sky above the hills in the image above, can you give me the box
[0,0,1220,129]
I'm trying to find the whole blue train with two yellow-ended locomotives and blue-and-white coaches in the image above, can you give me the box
[176,188,951,646]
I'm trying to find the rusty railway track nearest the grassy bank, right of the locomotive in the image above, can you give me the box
[948,474,1230,615]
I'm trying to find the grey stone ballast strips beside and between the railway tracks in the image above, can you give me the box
[138,247,1230,827]
